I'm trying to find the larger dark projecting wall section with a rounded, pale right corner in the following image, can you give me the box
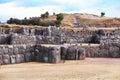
[35,45,61,63]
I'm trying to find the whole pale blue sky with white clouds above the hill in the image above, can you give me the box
[0,0,120,22]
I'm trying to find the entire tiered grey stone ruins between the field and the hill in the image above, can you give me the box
[0,26,120,64]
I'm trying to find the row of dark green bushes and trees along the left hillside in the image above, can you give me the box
[7,12,64,27]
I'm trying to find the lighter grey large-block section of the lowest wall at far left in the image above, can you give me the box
[0,45,34,64]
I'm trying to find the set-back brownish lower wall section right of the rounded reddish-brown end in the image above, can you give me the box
[82,43,120,58]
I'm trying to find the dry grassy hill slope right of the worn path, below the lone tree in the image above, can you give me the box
[74,13,120,27]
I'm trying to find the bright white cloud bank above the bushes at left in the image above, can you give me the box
[0,2,61,21]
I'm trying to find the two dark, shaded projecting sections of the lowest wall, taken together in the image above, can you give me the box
[35,45,86,63]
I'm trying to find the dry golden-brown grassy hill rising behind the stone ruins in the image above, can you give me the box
[0,13,120,28]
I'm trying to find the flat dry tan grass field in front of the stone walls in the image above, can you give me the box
[0,58,120,80]
